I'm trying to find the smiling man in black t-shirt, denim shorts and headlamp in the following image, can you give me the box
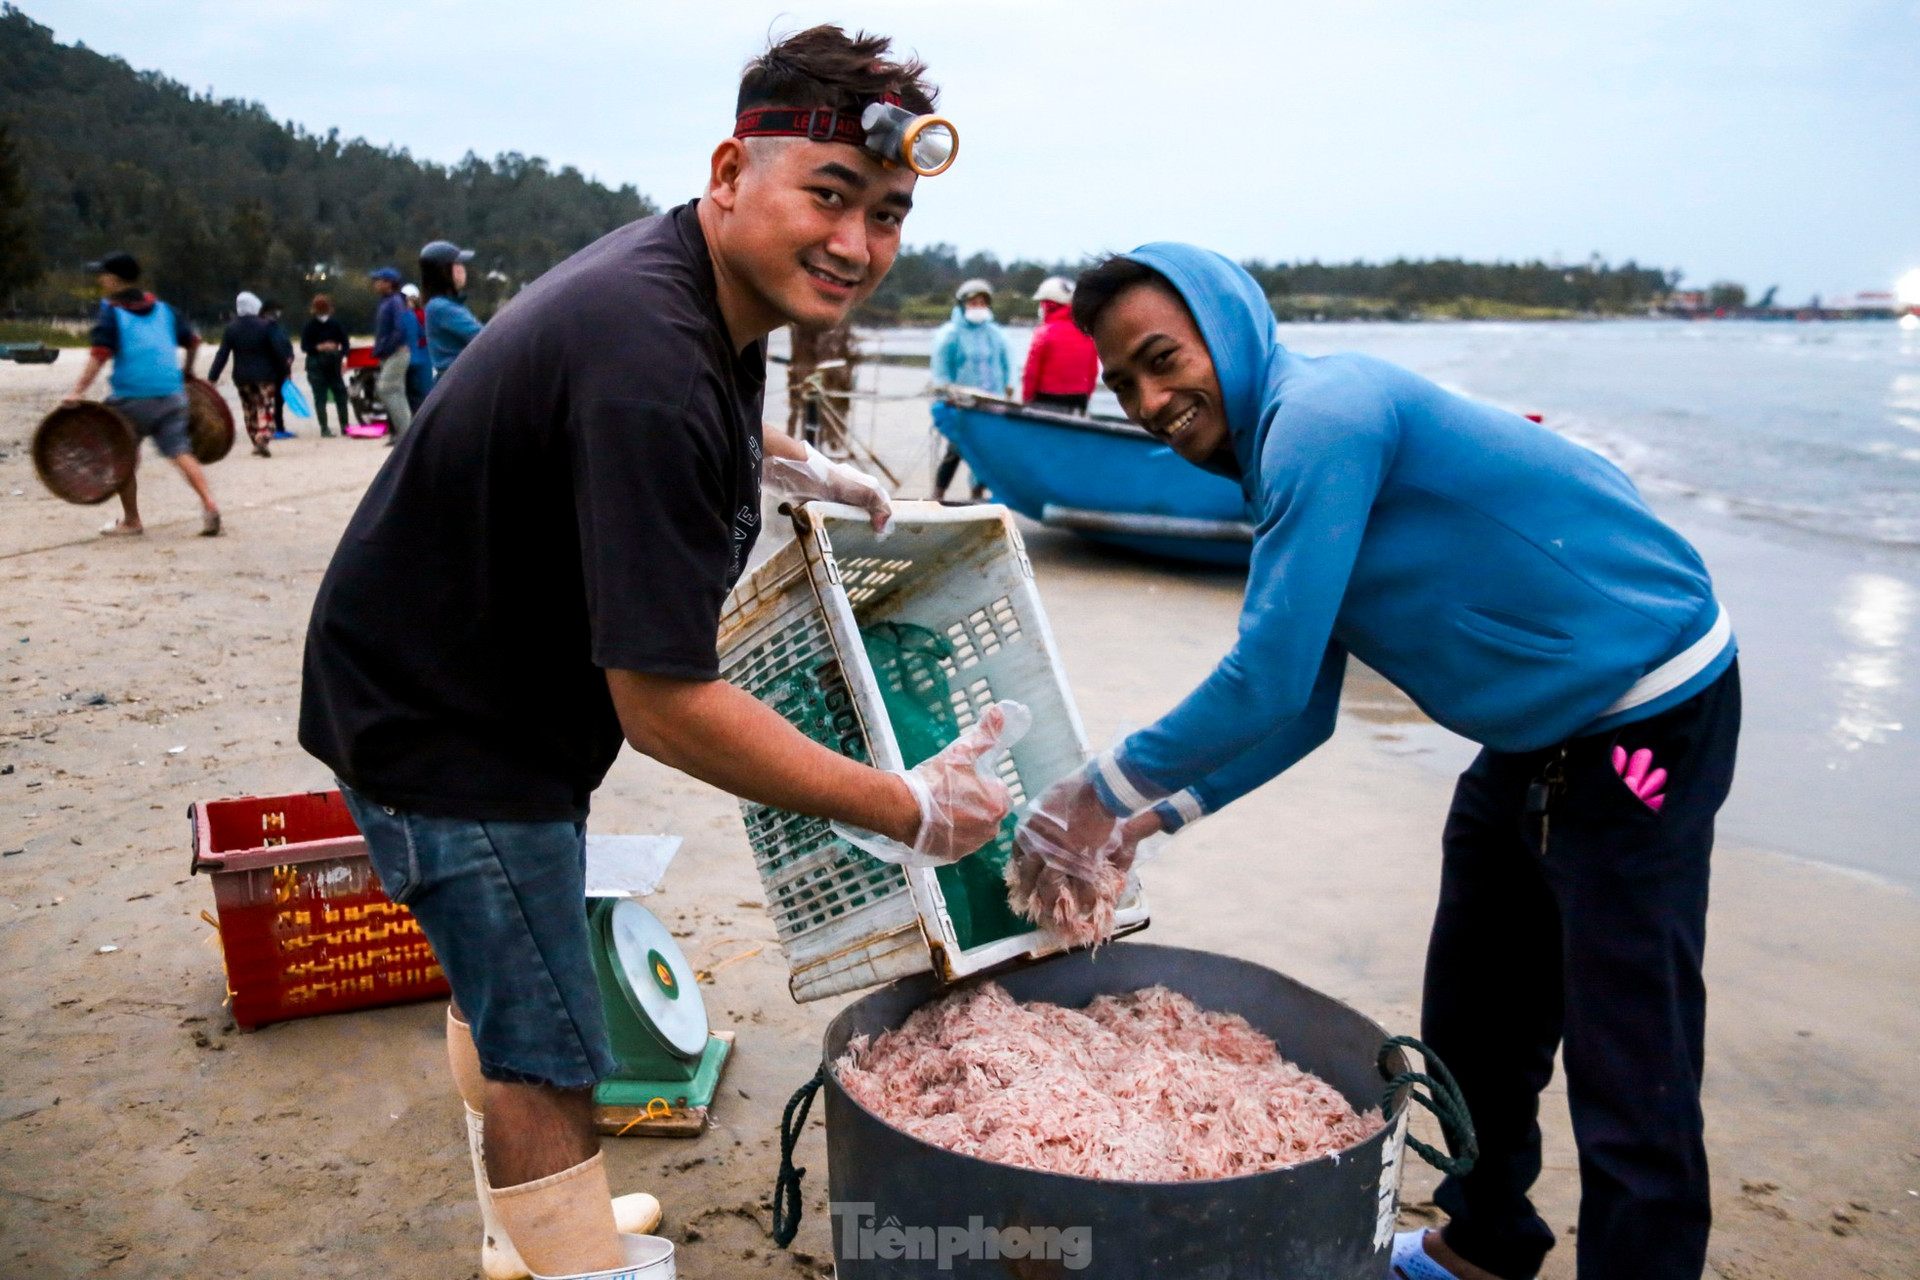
[300,27,1008,1276]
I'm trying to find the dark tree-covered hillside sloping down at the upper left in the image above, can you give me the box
[0,4,655,326]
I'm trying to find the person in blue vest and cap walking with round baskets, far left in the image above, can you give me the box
[65,253,221,537]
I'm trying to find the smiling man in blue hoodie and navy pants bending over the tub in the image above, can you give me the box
[1018,244,1740,1280]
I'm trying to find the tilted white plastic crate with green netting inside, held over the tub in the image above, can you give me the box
[720,503,1148,1000]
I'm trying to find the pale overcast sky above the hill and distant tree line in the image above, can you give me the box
[21,0,1920,301]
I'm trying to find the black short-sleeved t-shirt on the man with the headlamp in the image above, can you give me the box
[300,203,766,821]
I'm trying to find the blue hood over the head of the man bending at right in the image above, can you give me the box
[1123,240,1286,487]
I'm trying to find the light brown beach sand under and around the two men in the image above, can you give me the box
[0,353,1920,1280]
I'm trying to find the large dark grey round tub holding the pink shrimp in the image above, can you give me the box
[824,942,1407,1280]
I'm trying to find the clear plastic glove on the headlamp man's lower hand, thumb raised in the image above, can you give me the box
[833,702,1033,867]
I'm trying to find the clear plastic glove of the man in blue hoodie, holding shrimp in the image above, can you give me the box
[1006,766,1160,946]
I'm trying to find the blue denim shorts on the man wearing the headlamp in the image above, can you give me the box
[340,785,614,1088]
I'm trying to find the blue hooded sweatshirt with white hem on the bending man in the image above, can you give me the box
[1094,244,1734,831]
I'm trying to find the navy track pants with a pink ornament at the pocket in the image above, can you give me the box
[1421,662,1740,1280]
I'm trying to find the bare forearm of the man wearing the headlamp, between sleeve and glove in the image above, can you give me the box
[607,672,920,844]
